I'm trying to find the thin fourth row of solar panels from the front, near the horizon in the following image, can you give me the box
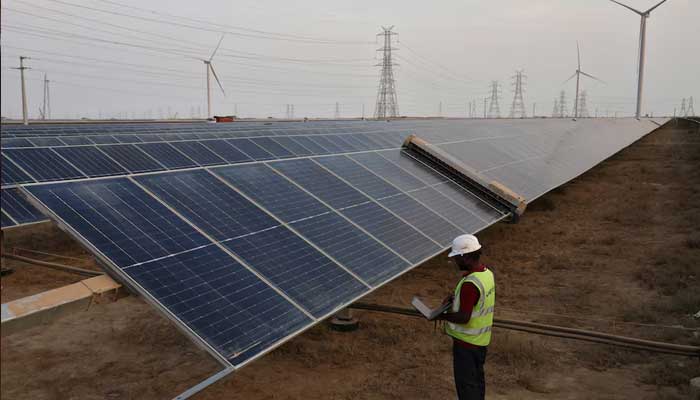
[0,122,405,138]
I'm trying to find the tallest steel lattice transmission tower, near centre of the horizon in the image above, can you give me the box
[374,25,399,119]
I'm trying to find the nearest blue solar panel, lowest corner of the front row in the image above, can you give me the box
[125,246,313,364]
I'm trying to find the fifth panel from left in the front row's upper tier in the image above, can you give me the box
[314,156,401,199]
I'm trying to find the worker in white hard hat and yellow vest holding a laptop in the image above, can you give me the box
[438,235,496,400]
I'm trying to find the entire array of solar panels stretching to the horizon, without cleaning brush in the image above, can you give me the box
[3,120,668,368]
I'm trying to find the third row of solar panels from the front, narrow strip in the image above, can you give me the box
[0,126,410,148]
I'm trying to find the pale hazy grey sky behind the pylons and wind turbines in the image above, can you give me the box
[1,0,700,118]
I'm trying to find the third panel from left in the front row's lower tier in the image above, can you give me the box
[291,213,409,286]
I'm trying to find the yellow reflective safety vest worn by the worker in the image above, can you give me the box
[445,269,496,346]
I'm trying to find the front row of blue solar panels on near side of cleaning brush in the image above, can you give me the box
[24,150,502,366]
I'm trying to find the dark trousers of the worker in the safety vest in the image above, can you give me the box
[452,343,486,400]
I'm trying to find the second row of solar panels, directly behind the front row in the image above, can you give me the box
[2,133,406,186]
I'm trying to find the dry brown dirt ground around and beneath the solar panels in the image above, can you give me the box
[0,120,700,400]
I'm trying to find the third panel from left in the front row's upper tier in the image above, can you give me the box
[211,164,330,222]
